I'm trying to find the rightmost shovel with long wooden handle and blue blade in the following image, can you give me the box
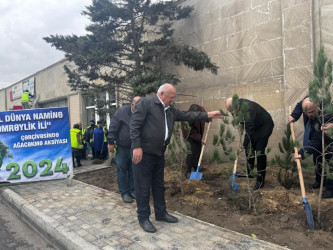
[289,106,314,229]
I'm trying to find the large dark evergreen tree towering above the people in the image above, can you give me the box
[44,0,218,116]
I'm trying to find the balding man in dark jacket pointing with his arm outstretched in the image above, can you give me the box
[130,83,223,233]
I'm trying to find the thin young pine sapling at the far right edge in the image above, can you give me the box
[309,47,333,222]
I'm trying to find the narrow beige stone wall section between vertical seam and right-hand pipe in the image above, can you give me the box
[281,0,315,142]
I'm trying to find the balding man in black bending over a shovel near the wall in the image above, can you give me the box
[225,98,274,190]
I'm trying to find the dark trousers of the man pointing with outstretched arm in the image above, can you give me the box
[133,153,166,221]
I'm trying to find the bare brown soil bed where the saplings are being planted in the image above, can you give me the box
[75,160,333,250]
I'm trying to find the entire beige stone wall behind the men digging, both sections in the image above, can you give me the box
[169,0,322,160]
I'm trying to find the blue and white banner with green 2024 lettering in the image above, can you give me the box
[0,108,73,183]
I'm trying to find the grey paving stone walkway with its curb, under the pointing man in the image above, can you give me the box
[3,180,285,250]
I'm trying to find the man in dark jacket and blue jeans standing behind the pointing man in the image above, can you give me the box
[108,96,140,203]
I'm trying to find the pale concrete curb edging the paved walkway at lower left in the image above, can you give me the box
[2,189,98,250]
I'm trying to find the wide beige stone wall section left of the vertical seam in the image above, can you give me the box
[174,0,287,158]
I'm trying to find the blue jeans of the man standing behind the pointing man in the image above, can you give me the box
[116,146,134,195]
